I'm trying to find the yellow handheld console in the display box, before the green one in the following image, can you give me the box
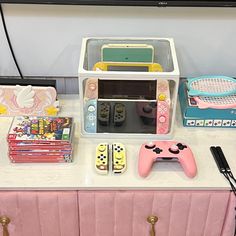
[93,62,163,72]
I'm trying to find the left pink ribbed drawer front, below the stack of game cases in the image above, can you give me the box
[0,191,79,236]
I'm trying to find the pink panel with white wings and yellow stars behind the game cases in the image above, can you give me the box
[0,85,59,116]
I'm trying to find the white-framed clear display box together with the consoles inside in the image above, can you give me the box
[78,37,179,139]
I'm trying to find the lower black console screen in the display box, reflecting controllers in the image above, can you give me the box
[96,100,157,134]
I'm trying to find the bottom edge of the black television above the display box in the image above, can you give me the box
[0,0,236,7]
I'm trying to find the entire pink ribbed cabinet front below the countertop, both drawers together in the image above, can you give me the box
[0,190,235,236]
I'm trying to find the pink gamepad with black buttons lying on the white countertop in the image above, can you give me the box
[138,141,197,178]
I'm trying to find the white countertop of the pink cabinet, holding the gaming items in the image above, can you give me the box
[0,95,236,190]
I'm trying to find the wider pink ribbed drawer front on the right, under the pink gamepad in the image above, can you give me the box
[79,191,235,236]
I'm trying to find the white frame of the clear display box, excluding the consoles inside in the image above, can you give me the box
[78,37,179,139]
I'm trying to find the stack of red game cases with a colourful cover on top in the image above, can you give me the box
[8,116,73,163]
